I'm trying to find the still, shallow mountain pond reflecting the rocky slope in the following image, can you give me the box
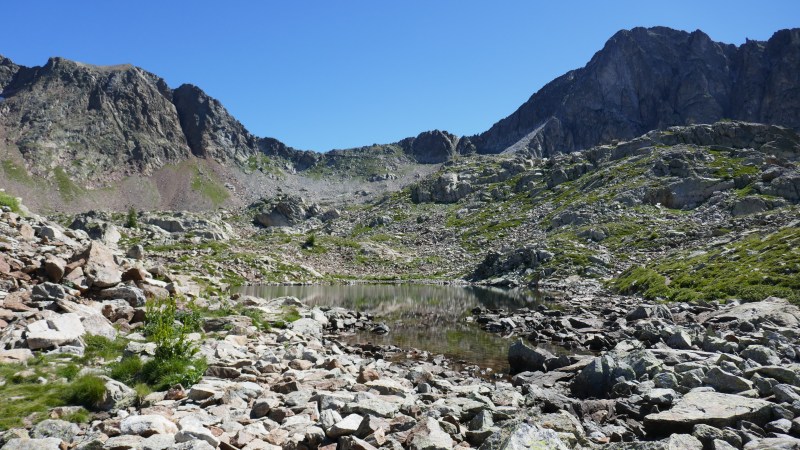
[234,284,557,372]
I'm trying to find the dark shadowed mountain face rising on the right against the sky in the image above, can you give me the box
[469,27,800,156]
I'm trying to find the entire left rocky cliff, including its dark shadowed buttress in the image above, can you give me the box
[0,58,284,182]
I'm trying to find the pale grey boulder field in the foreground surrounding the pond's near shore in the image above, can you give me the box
[0,205,800,450]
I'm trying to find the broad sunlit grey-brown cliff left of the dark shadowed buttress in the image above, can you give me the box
[0,58,189,178]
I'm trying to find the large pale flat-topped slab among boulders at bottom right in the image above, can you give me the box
[645,392,772,434]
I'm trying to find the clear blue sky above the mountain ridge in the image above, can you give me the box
[0,0,800,151]
